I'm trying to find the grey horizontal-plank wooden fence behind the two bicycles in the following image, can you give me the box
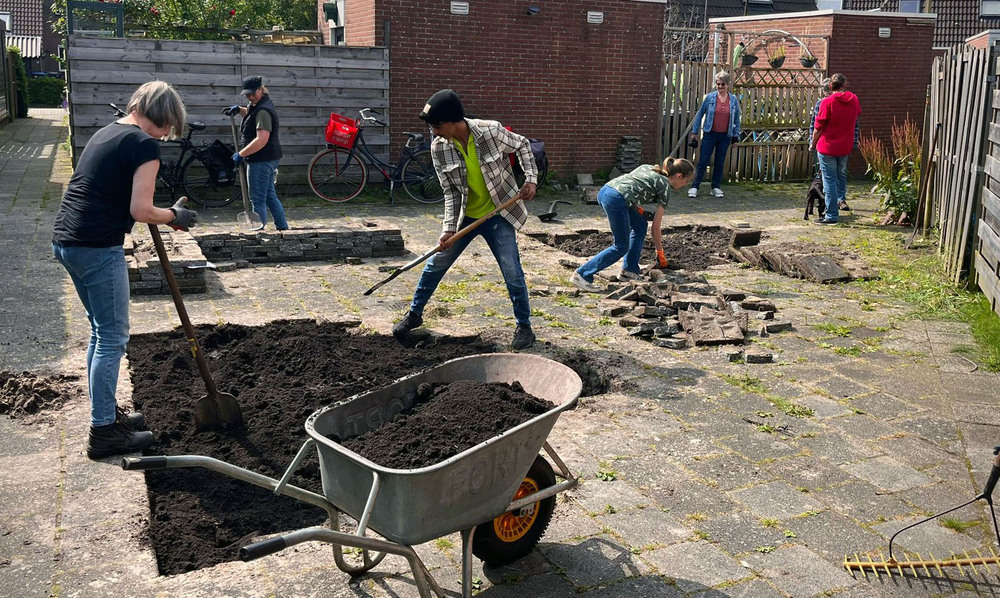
[67,35,391,192]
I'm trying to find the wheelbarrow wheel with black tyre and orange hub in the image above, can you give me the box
[472,456,556,567]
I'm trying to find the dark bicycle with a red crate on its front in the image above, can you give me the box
[309,108,444,204]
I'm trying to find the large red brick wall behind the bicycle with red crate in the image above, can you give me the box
[346,0,664,177]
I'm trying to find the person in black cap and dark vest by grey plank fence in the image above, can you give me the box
[222,77,288,230]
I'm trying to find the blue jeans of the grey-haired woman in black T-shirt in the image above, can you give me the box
[52,243,129,426]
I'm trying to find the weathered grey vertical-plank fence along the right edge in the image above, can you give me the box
[924,49,1000,288]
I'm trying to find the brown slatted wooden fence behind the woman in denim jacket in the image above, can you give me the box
[659,60,825,182]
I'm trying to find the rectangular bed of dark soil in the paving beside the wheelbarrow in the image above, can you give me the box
[128,320,607,575]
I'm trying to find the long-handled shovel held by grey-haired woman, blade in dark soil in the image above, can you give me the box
[149,224,243,430]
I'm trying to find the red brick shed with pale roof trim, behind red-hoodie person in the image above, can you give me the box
[712,11,935,175]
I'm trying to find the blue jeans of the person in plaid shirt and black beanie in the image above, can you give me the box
[410,214,531,326]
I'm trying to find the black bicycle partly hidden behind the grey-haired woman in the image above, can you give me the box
[108,104,240,208]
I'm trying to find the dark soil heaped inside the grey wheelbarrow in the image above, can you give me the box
[334,380,555,469]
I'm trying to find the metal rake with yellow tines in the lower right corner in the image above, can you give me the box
[844,446,1000,578]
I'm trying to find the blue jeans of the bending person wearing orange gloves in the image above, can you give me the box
[577,185,649,282]
